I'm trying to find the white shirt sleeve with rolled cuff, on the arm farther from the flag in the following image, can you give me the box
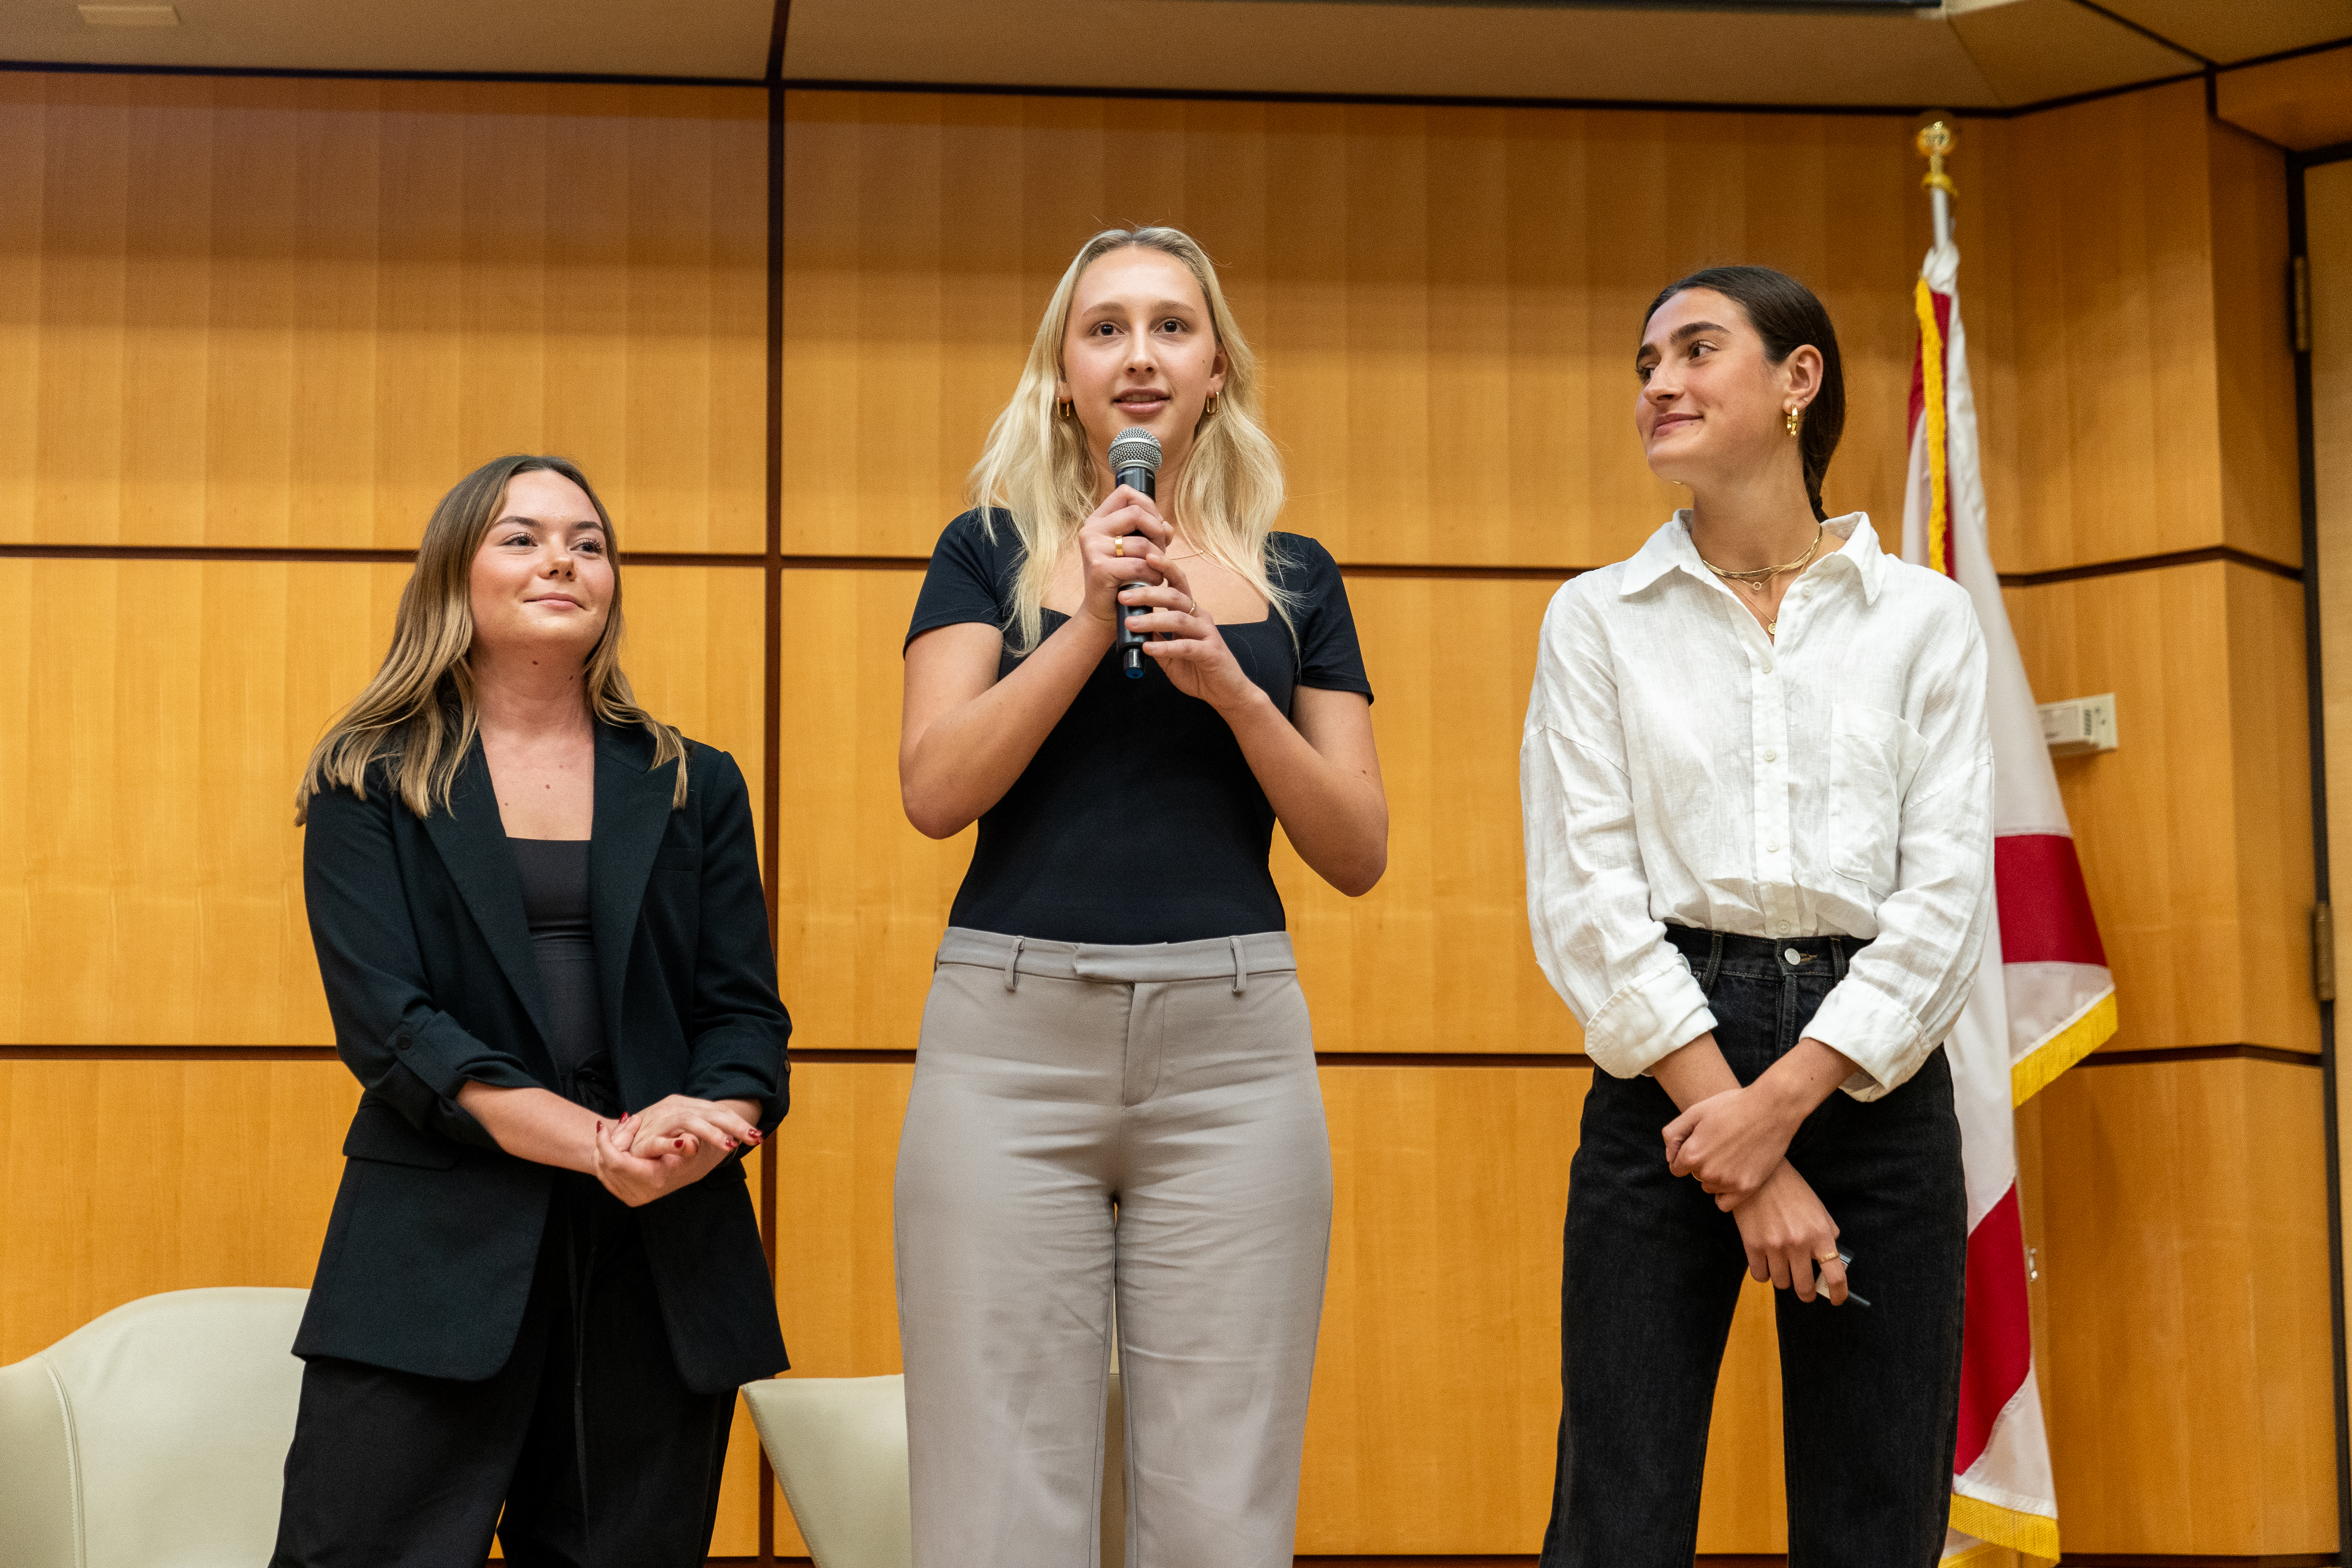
[1519,583,1715,1079]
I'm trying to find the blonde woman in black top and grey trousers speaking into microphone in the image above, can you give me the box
[896,228,1388,1568]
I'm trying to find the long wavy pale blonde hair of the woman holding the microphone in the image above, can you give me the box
[969,228,1296,653]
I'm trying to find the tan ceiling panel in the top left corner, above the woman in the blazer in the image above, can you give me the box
[0,0,774,78]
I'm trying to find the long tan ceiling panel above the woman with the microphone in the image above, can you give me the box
[783,0,2192,108]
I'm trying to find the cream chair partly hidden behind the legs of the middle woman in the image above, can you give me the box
[743,1366,1127,1568]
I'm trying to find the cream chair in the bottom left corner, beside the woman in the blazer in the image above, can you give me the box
[0,1288,310,1568]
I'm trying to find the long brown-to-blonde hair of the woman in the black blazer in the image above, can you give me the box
[294,456,687,825]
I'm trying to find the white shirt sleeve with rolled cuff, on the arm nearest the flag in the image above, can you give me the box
[1804,606,1992,1100]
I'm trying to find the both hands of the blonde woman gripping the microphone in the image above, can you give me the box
[1077,484,1258,710]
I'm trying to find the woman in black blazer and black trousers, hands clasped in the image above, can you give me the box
[273,456,793,1568]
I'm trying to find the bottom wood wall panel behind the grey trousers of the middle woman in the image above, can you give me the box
[771,1062,1785,1554]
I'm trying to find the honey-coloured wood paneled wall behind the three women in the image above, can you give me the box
[0,73,2333,1554]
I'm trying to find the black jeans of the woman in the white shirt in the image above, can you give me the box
[1543,926,1969,1568]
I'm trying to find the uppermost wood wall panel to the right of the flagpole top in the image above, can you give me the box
[1962,82,2303,571]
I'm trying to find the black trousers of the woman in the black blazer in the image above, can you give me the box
[270,1173,734,1568]
